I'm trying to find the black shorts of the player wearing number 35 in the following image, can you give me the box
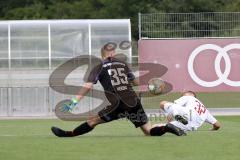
[98,100,148,128]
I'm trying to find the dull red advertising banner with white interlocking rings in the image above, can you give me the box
[138,39,240,92]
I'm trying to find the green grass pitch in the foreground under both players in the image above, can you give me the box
[0,116,240,160]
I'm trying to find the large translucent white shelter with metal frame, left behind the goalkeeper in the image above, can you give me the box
[0,19,131,117]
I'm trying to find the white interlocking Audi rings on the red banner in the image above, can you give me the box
[188,44,240,87]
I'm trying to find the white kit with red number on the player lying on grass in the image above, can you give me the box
[166,96,217,131]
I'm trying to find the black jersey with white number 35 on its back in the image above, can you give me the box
[88,58,137,107]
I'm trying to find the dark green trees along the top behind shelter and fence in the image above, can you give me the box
[0,0,240,39]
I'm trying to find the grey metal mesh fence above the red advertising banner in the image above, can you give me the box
[139,12,240,39]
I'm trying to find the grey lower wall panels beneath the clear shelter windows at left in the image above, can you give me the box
[0,86,101,117]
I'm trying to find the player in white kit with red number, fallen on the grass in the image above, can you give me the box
[151,91,221,134]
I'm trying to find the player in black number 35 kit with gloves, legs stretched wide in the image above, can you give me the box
[51,44,186,137]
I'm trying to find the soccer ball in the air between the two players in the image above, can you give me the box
[148,78,165,94]
